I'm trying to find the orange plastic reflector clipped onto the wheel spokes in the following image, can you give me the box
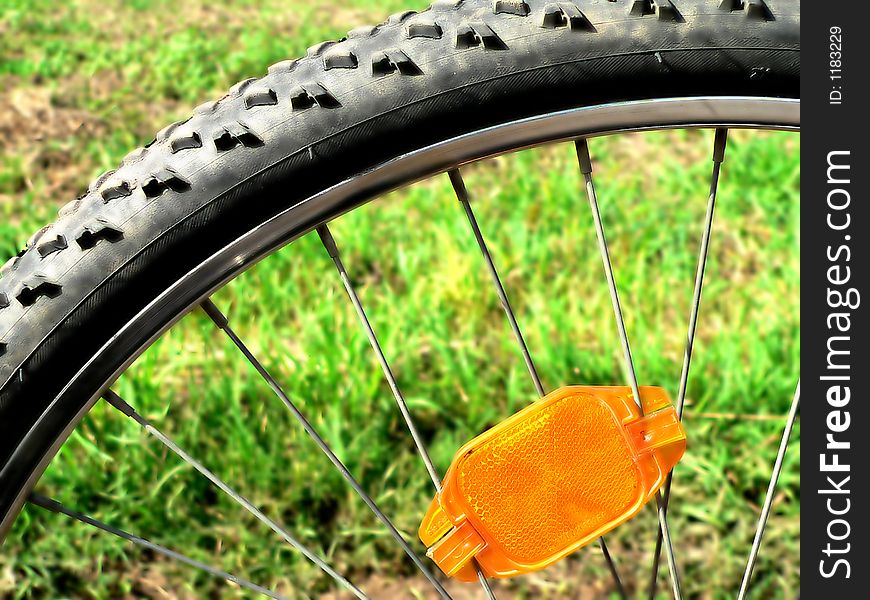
[419,386,686,581]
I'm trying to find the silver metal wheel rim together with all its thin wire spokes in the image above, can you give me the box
[0,97,800,598]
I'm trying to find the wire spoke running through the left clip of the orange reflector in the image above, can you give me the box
[317,225,495,600]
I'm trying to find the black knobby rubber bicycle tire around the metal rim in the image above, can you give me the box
[0,0,800,539]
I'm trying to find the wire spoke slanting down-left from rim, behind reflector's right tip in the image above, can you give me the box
[649,128,728,600]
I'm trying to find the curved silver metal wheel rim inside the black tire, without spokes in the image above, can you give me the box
[0,96,800,591]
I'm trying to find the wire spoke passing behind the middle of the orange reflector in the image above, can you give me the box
[448,169,628,599]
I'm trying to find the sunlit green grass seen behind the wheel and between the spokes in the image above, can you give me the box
[0,0,800,598]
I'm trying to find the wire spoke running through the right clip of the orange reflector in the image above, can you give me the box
[574,139,683,600]
